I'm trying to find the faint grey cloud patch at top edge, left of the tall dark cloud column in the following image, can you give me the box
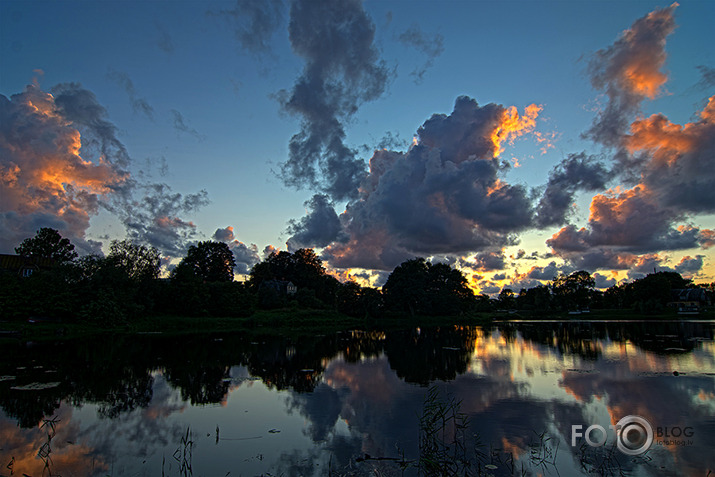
[209,0,284,53]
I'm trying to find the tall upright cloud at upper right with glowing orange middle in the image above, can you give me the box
[586,3,678,146]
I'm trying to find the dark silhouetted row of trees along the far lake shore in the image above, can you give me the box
[0,228,715,325]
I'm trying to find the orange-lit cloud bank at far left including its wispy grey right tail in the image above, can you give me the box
[0,83,207,253]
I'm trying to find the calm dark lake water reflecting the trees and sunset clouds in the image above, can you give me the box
[0,322,715,477]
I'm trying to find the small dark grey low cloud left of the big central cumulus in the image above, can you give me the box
[287,194,347,250]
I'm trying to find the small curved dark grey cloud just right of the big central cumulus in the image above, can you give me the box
[536,153,610,227]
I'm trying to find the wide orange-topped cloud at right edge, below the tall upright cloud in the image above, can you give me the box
[547,97,715,267]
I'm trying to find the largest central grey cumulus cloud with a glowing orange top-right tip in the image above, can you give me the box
[324,97,540,270]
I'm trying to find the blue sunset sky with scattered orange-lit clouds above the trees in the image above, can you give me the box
[0,0,715,294]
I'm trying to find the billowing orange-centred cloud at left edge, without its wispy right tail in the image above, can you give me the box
[0,85,129,251]
